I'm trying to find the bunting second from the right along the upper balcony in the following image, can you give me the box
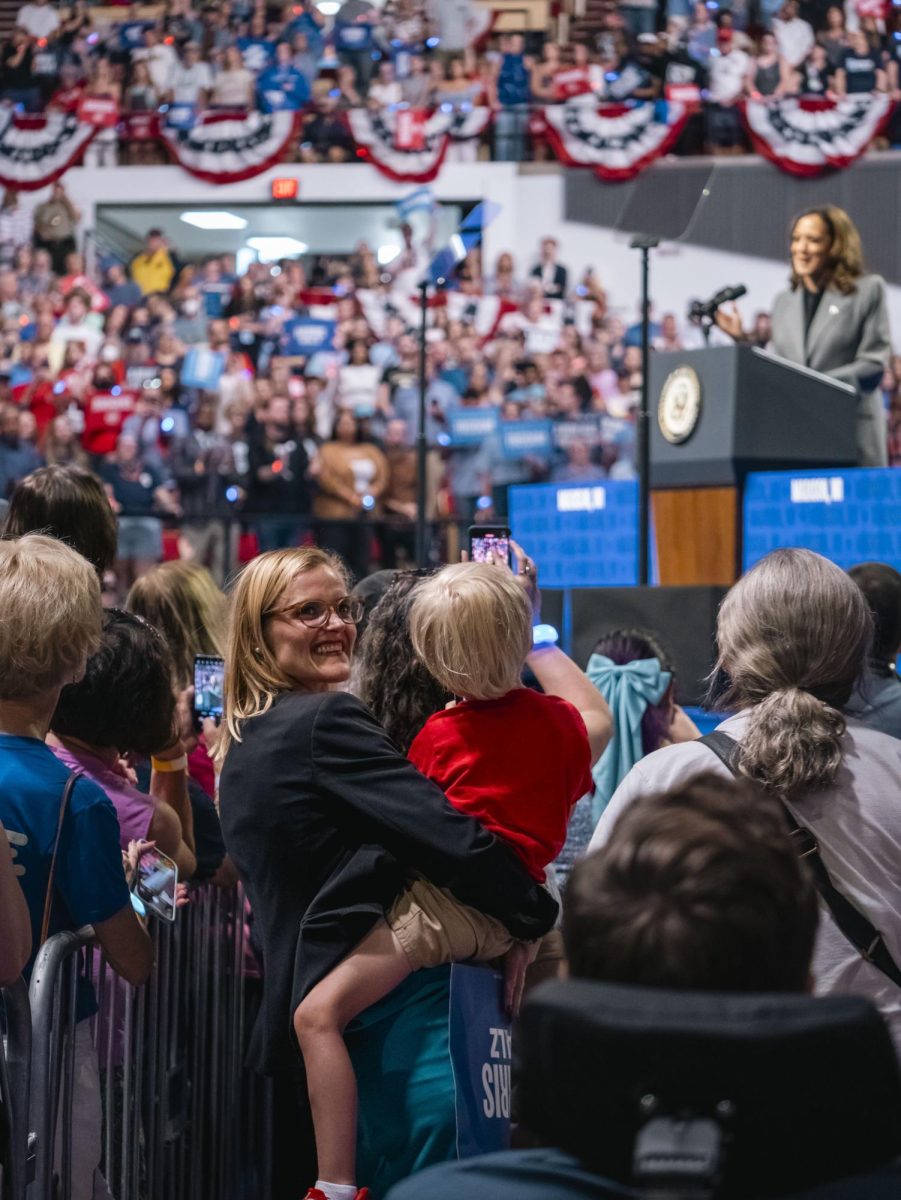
[540,101,691,181]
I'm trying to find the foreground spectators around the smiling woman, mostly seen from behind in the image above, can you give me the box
[0,451,901,1200]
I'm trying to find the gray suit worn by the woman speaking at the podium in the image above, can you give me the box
[773,275,891,467]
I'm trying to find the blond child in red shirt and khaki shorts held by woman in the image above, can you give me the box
[294,556,611,1200]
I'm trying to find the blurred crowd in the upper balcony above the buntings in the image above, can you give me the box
[0,0,901,164]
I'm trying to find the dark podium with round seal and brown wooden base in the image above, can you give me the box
[649,346,858,586]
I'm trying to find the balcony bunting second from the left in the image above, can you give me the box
[160,109,298,184]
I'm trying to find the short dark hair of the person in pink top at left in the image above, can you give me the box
[50,608,175,755]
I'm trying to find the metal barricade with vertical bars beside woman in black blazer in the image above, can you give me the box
[29,886,271,1200]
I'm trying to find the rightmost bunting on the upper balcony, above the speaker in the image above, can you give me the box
[743,92,893,176]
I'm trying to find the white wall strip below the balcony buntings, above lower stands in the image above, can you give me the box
[38,162,901,343]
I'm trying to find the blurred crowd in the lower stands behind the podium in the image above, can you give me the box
[0,184,710,589]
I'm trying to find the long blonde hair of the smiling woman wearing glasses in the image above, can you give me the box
[216,546,350,767]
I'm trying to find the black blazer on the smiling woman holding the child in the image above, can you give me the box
[220,692,557,1072]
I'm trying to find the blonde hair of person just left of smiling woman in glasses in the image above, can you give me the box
[125,562,228,689]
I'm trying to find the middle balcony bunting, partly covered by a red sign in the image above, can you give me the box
[347,106,491,184]
